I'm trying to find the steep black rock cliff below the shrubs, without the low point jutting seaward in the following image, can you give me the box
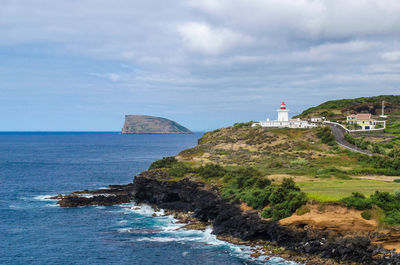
[134,172,400,264]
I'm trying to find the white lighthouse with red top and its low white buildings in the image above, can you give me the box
[252,101,317,128]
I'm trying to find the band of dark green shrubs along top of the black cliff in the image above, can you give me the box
[150,157,307,221]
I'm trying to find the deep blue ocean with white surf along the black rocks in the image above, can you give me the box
[0,133,291,264]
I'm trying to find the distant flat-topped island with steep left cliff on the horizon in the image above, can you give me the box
[122,115,192,134]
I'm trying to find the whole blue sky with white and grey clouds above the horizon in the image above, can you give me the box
[0,0,400,131]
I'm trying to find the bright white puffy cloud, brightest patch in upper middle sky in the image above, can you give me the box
[178,22,251,54]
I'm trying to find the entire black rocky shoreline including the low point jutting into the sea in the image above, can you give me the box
[53,171,400,265]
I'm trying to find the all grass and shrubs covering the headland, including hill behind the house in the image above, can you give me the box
[150,96,400,224]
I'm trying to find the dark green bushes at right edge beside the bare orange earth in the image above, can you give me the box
[342,191,400,225]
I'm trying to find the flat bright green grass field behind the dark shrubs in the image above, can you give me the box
[297,179,400,202]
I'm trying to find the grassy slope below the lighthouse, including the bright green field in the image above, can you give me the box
[178,127,400,201]
